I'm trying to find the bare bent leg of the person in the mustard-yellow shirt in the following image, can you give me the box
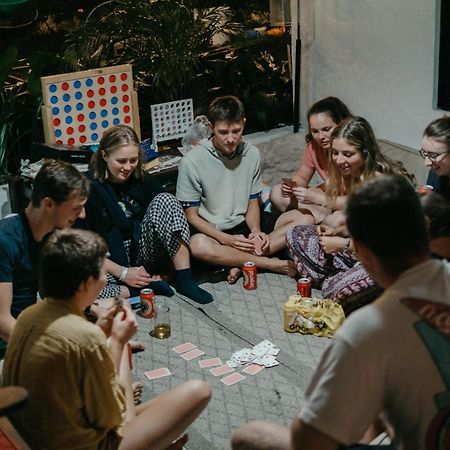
[119,380,211,450]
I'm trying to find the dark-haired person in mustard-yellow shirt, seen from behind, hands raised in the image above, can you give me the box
[3,230,211,450]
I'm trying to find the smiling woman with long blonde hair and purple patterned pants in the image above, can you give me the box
[286,117,414,313]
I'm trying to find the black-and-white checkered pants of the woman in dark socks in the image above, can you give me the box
[99,192,190,298]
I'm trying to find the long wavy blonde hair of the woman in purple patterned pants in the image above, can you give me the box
[325,117,415,200]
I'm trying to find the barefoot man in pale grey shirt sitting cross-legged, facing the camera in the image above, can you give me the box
[176,96,296,284]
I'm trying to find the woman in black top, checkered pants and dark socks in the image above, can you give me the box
[78,125,213,304]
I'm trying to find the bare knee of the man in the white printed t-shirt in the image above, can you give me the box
[231,422,291,450]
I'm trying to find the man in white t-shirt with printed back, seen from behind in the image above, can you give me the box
[233,175,450,450]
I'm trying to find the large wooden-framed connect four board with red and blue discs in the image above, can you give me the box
[41,64,140,146]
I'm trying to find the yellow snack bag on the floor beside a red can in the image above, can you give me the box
[284,295,345,337]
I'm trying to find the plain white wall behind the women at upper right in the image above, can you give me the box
[291,0,443,148]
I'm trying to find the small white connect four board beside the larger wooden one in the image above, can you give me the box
[151,98,194,142]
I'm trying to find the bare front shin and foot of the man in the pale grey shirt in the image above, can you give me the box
[191,233,296,277]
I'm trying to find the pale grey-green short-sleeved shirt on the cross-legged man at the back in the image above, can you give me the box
[176,139,261,230]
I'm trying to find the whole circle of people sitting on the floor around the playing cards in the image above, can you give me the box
[0,96,450,449]
